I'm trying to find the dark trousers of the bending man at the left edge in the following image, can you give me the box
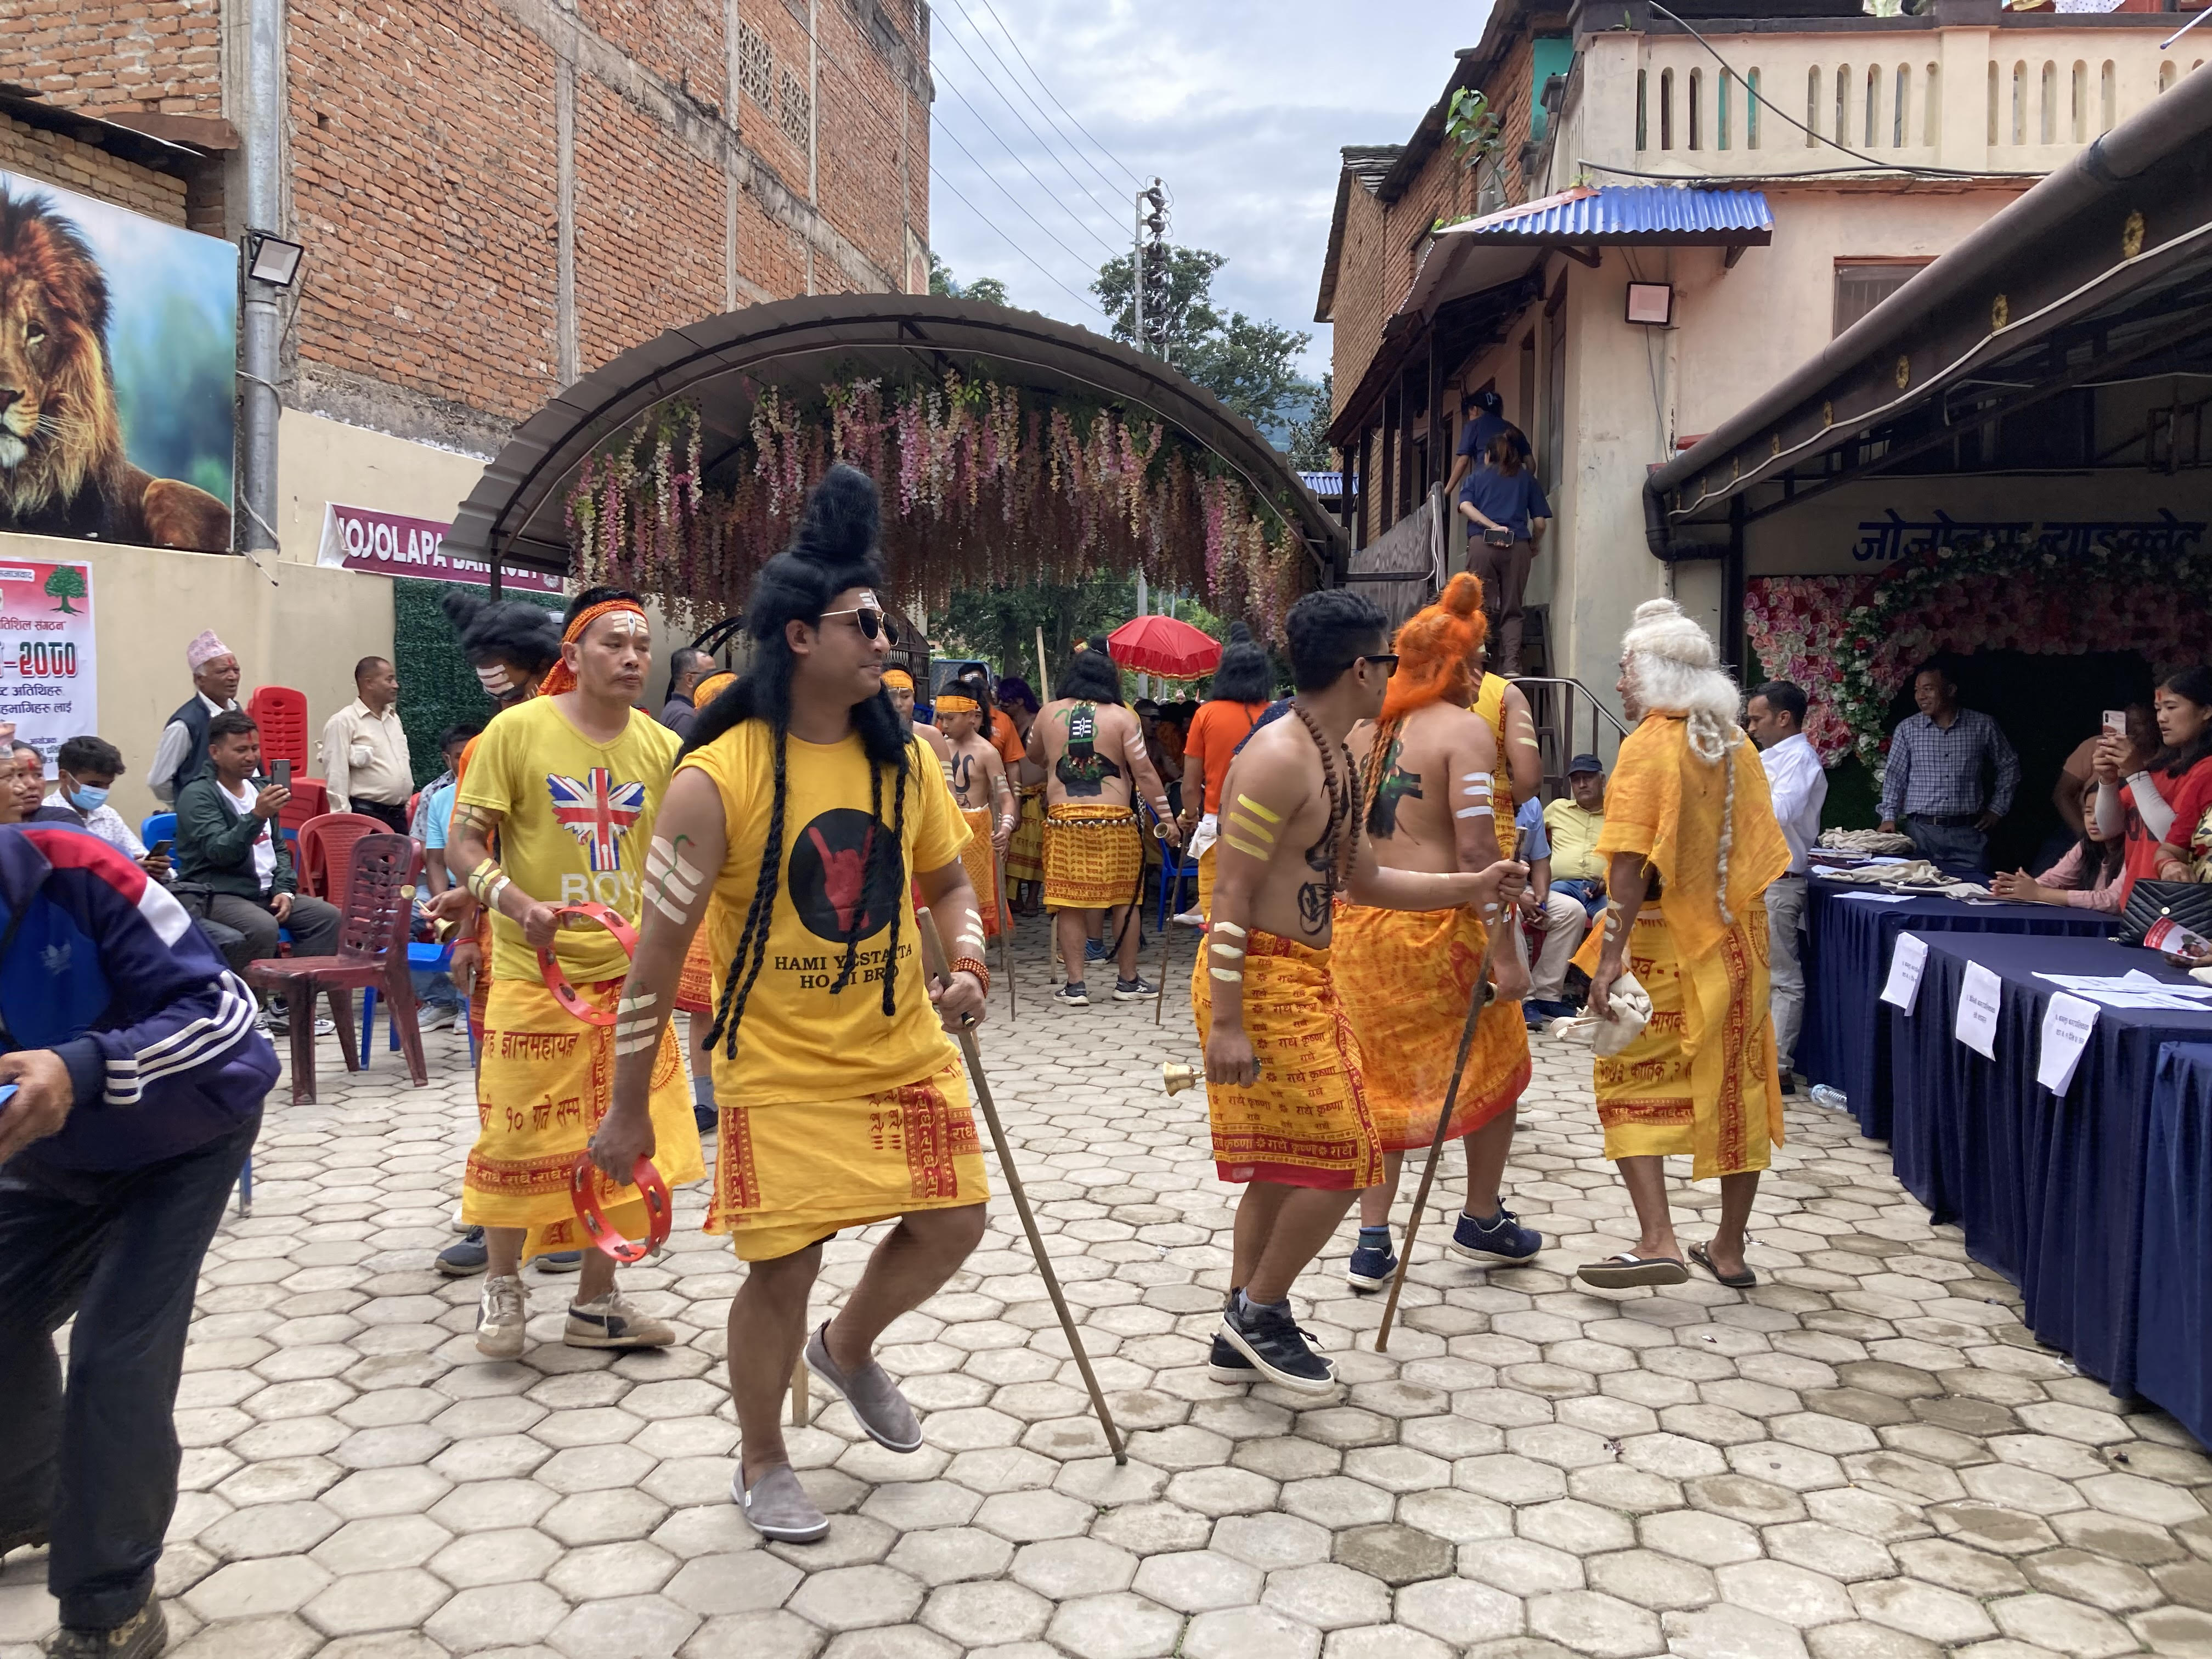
[0,1119,261,1630]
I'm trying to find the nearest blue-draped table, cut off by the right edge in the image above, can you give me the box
[2135,1042,2212,1444]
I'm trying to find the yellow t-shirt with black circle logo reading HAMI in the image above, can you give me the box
[684,721,969,1106]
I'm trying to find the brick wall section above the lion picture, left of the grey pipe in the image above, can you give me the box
[0,0,223,115]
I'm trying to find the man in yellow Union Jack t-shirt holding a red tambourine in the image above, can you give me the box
[447,589,706,1358]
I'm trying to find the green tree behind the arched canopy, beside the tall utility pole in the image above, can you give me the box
[1091,246,1314,444]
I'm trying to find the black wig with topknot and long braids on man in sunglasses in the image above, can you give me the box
[684,465,913,1059]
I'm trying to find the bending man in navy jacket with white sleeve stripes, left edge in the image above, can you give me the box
[0,823,276,1659]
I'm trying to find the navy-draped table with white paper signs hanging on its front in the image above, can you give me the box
[1889,934,2212,1393]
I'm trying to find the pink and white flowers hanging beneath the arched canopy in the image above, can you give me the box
[566,371,1310,637]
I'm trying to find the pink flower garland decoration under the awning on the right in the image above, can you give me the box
[1745,535,2212,772]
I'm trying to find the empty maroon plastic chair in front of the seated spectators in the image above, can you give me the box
[246,825,429,1106]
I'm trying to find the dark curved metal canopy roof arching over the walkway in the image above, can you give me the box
[444,294,1350,582]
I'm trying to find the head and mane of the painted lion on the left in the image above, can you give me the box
[0,193,122,513]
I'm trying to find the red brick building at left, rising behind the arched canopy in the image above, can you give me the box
[0,0,931,487]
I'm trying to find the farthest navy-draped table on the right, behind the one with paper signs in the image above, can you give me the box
[1794,876,2117,1142]
